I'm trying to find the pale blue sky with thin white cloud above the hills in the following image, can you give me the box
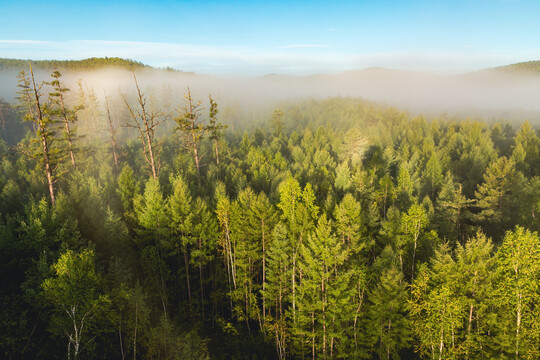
[0,0,540,75]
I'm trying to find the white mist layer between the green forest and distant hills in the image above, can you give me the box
[0,68,540,120]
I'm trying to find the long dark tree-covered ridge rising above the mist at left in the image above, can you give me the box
[0,57,153,71]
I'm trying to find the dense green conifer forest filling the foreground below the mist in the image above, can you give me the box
[0,59,540,360]
